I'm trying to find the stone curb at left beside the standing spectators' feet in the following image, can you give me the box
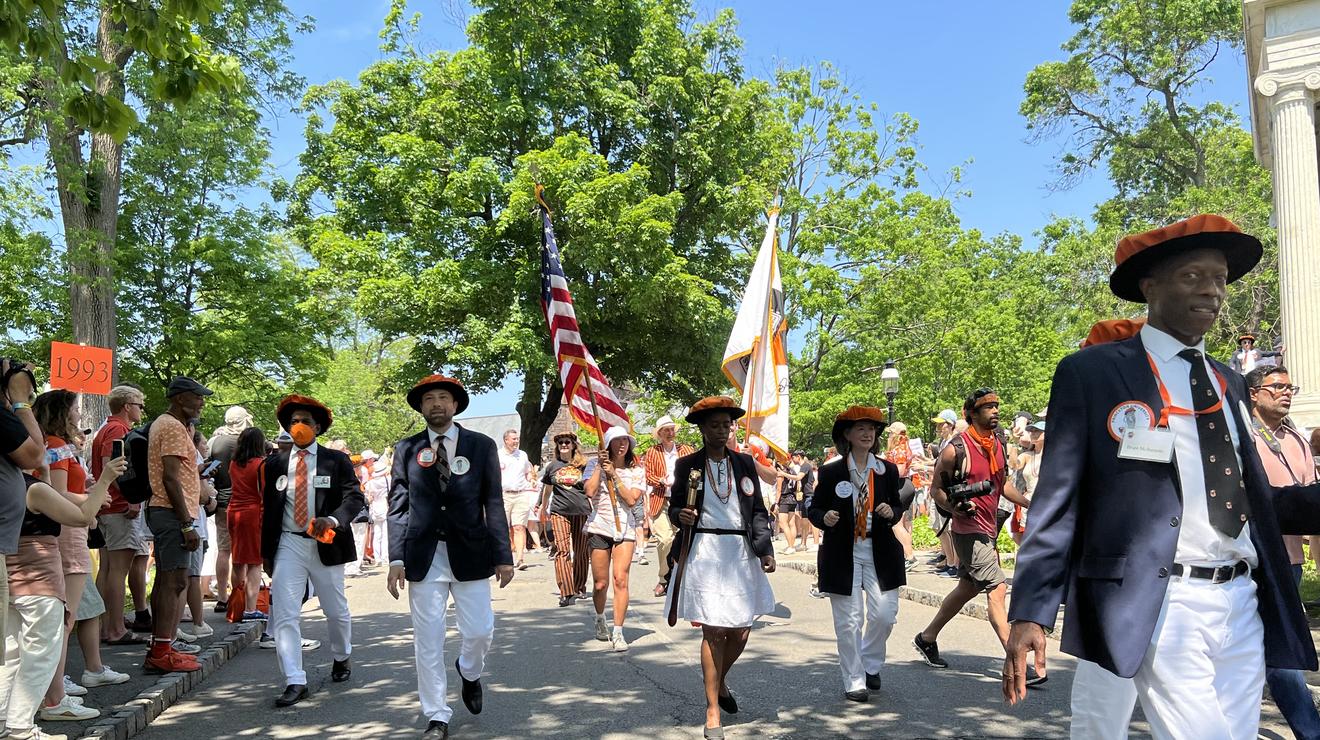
[79,621,261,740]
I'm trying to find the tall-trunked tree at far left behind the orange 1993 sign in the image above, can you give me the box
[0,0,299,418]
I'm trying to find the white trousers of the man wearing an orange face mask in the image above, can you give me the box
[271,532,352,685]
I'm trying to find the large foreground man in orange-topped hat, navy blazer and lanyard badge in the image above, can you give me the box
[1003,215,1320,739]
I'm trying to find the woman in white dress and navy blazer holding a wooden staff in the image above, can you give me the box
[665,396,775,737]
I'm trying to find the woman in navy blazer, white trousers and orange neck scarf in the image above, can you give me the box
[807,406,907,702]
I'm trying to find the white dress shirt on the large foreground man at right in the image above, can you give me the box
[1142,323,1257,567]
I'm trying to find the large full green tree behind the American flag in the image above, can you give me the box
[288,0,774,456]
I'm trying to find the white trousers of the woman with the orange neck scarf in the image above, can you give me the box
[829,540,899,691]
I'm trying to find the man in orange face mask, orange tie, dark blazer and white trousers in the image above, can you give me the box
[261,396,366,707]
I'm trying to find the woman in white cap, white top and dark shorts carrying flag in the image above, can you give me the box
[583,426,647,653]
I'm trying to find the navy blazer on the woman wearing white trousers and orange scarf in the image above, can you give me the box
[807,458,911,596]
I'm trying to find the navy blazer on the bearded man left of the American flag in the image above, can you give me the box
[387,423,513,582]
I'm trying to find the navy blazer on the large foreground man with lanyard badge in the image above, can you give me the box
[1008,335,1320,677]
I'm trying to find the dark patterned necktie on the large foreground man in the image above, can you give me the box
[1177,350,1251,537]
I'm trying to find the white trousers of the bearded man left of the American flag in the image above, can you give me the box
[408,542,495,722]
